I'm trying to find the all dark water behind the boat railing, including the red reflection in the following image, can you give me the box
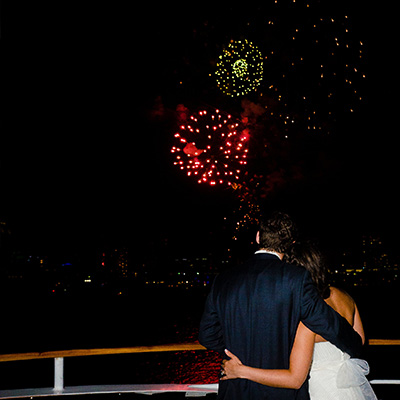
[0,289,400,390]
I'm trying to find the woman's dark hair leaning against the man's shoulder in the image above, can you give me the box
[286,241,330,299]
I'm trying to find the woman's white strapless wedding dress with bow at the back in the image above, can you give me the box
[309,342,377,400]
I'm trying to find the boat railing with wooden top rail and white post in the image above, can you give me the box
[0,339,400,399]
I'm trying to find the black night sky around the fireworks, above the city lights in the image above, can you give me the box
[0,0,399,260]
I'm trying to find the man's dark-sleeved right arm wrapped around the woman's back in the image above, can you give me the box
[300,272,362,357]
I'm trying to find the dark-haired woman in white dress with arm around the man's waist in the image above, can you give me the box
[221,243,376,400]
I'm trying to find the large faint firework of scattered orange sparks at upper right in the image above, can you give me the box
[252,1,366,132]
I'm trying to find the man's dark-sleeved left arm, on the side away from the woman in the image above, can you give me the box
[199,278,225,353]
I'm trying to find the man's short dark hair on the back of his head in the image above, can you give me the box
[259,211,297,253]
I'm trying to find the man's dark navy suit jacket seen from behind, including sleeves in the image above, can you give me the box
[199,253,362,400]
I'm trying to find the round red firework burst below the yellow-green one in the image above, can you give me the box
[171,110,249,185]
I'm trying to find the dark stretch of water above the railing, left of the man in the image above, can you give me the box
[0,289,206,353]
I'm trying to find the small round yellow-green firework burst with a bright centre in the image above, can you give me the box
[216,39,263,97]
